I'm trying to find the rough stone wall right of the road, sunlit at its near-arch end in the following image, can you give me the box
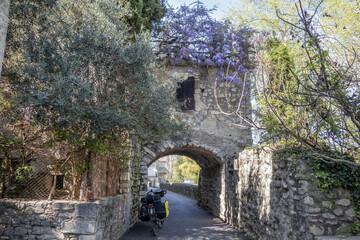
[231,148,360,239]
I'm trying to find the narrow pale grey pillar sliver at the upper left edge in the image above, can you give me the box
[0,0,10,74]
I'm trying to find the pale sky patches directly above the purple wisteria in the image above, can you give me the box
[168,0,236,20]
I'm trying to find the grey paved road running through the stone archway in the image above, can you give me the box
[121,191,250,240]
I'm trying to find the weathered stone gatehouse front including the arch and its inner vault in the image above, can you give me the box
[141,65,252,216]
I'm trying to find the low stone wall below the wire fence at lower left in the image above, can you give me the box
[0,194,131,240]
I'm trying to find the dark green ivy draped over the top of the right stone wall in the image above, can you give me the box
[274,148,360,234]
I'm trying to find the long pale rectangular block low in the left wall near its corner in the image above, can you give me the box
[60,220,97,235]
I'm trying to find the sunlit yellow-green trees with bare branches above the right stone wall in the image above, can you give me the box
[232,0,360,162]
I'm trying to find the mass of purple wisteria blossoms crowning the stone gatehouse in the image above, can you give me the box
[154,1,251,83]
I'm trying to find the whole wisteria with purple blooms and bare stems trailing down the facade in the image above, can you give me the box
[153,1,252,125]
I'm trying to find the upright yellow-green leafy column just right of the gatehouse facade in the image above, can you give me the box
[256,39,303,141]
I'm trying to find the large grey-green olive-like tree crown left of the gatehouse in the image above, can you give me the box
[4,0,183,147]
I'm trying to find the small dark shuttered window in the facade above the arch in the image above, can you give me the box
[176,77,195,110]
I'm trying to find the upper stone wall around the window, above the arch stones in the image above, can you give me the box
[153,63,252,158]
